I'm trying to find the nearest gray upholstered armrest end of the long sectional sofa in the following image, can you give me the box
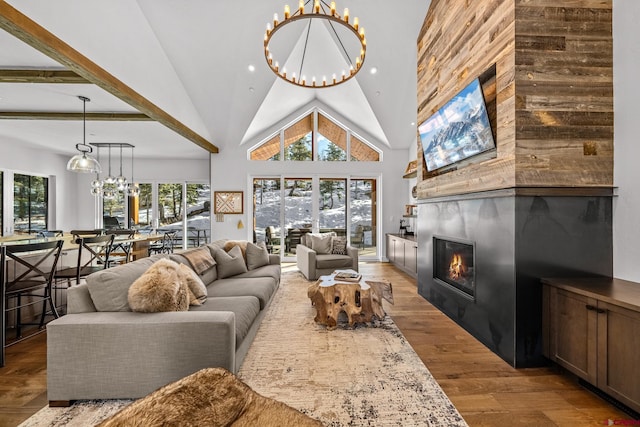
[47,311,236,401]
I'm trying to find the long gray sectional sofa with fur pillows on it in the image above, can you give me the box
[47,241,280,406]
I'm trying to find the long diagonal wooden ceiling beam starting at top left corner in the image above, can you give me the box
[0,1,218,153]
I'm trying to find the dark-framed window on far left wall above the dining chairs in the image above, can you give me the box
[13,174,49,234]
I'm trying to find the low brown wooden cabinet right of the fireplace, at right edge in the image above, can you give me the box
[543,278,640,411]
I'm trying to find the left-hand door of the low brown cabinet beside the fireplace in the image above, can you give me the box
[549,288,598,384]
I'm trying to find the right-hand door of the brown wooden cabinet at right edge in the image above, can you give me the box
[597,301,640,411]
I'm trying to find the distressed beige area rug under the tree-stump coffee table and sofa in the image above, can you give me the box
[20,271,467,427]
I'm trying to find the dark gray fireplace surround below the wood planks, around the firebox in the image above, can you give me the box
[417,188,613,368]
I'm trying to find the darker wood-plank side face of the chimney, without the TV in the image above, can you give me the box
[515,0,613,187]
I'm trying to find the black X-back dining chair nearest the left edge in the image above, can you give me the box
[0,240,64,366]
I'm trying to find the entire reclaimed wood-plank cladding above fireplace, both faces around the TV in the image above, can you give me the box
[417,0,613,199]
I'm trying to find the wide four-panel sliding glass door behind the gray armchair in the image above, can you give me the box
[253,177,378,261]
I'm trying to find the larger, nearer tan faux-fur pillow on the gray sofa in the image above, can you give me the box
[127,259,189,313]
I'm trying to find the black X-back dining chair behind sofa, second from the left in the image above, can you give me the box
[54,234,115,287]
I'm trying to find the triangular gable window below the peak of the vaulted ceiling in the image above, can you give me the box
[249,111,380,162]
